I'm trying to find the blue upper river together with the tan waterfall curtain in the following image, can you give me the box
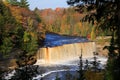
[37,33,96,63]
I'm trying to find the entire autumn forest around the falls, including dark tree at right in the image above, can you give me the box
[0,0,120,80]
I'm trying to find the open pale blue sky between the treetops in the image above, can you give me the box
[27,0,68,10]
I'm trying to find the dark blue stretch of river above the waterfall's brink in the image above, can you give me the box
[44,33,89,47]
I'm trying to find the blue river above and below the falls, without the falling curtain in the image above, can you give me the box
[2,33,107,80]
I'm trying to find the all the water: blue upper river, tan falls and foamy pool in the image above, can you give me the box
[5,33,107,80]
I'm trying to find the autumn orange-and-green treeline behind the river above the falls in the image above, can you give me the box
[34,7,110,38]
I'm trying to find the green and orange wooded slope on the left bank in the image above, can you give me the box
[0,0,44,72]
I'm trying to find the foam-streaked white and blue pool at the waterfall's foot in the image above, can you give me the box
[33,56,107,80]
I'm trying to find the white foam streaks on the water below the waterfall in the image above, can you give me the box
[33,57,107,80]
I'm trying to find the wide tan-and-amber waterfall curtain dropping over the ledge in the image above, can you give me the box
[36,42,96,63]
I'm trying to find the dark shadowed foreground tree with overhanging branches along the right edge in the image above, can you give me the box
[67,0,120,80]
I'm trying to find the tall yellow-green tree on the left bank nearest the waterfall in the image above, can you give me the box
[16,18,38,67]
